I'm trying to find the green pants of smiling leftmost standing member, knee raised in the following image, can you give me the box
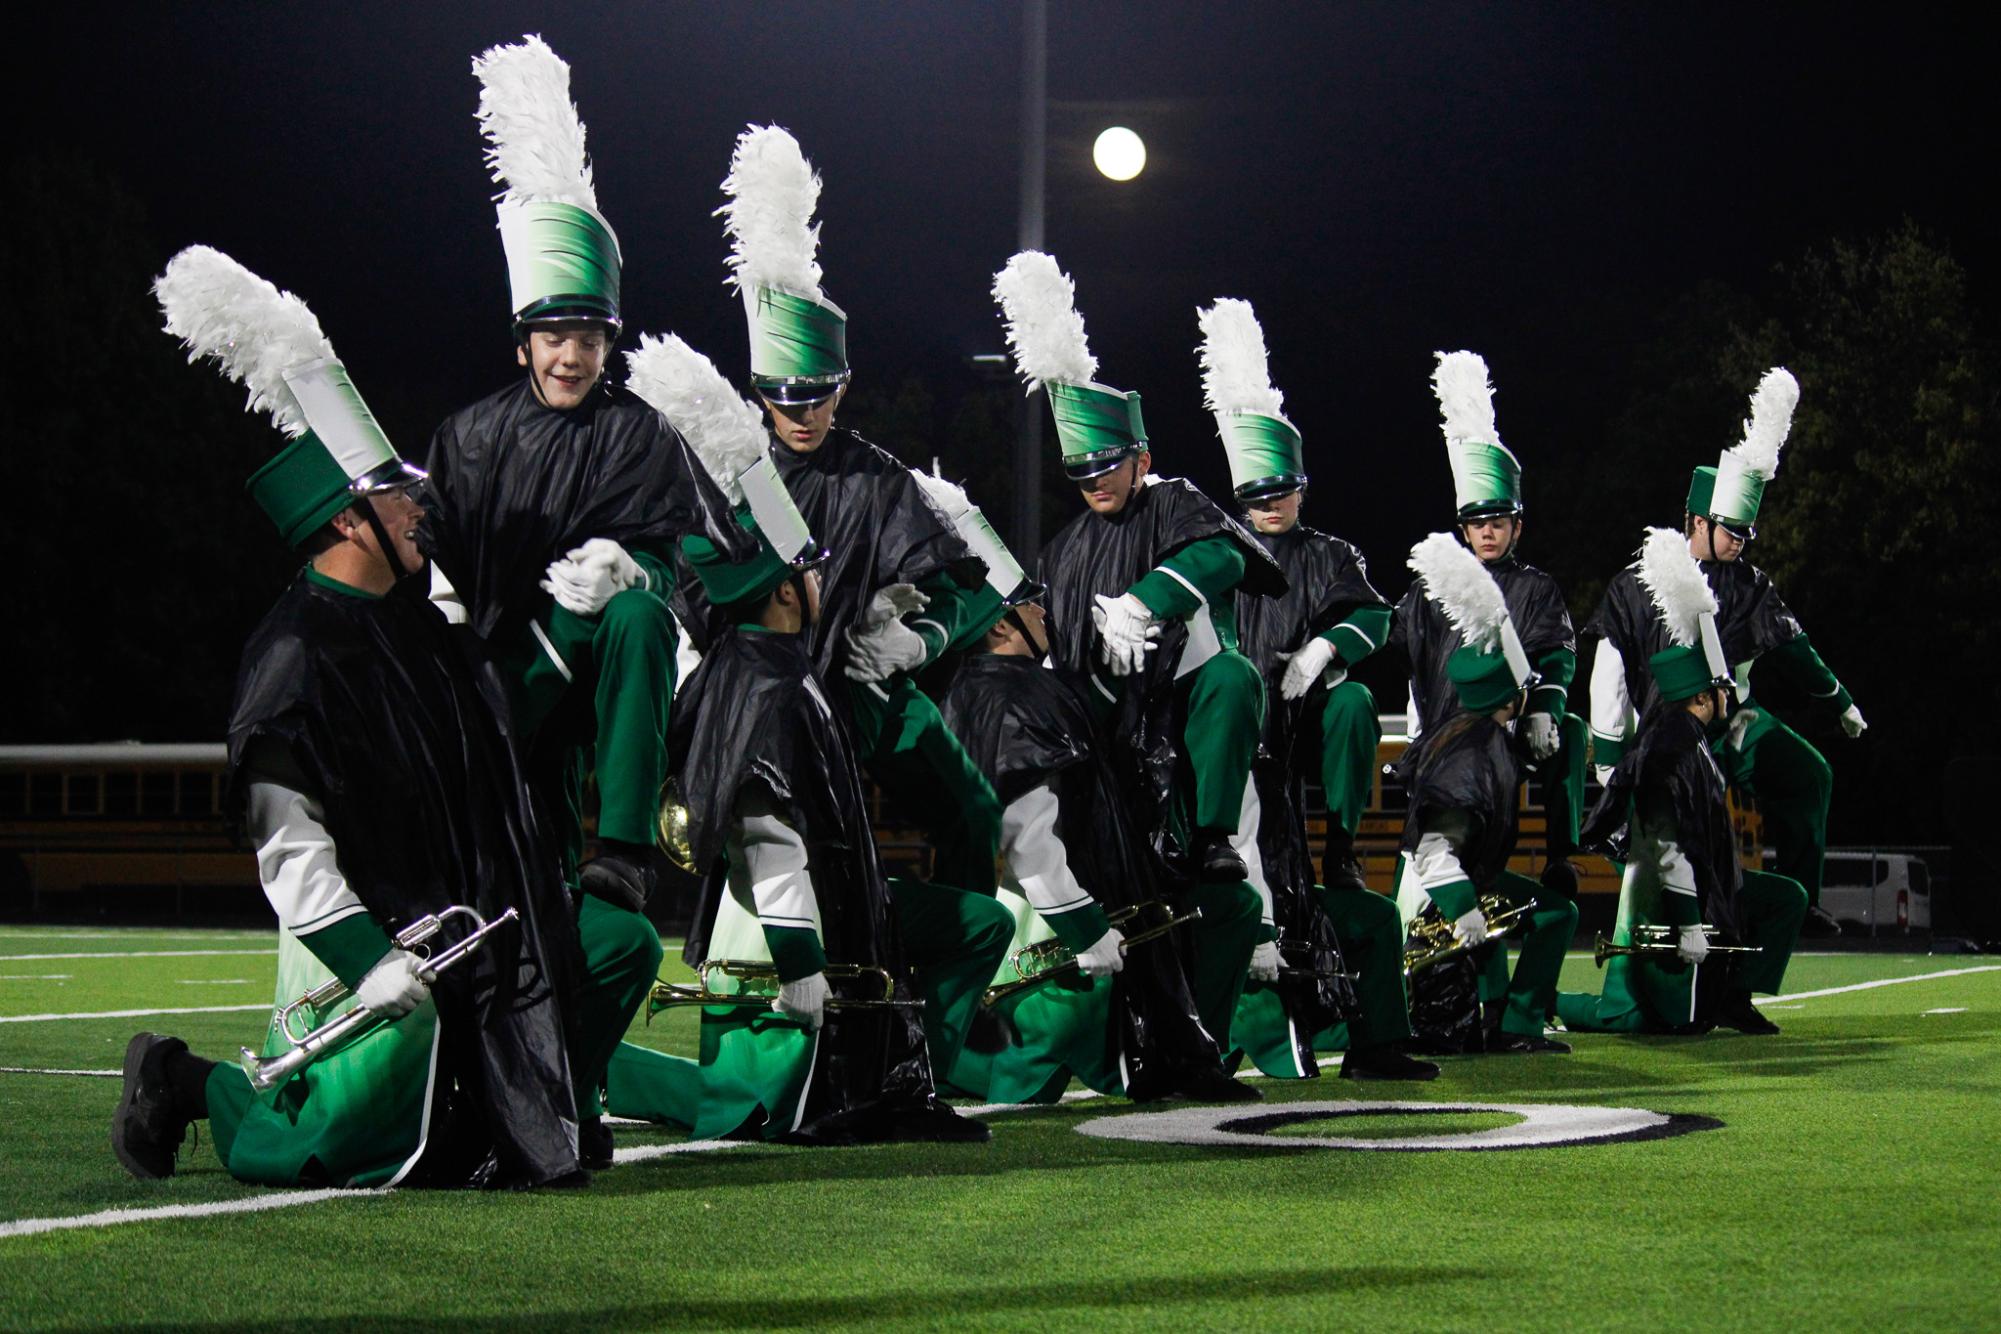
[508,588,678,868]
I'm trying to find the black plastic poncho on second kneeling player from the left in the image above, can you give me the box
[668,628,936,1138]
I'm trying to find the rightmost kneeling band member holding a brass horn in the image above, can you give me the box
[1557,528,1807,1034]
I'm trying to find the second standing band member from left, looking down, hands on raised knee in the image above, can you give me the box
[720,126,1001,894]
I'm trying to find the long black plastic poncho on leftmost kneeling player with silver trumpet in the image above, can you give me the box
[228,576,582,1184]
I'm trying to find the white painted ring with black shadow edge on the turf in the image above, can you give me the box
[1077,1102,1719,1154]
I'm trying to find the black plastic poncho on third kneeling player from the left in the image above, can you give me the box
[942,654,1221,1100]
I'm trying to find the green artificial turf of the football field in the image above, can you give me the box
[0,928,2001,1334]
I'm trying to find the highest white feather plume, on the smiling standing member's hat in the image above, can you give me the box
[472,36,598,212]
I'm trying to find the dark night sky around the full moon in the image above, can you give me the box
[12,0,1995,590]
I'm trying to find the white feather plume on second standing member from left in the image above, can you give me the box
[716,126,822,300]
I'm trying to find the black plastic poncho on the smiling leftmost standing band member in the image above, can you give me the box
[418,376,750,642]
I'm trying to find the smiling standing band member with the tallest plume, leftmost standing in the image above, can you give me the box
[422,38,742,1166]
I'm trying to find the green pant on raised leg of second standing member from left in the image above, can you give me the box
[842,674,1001,896]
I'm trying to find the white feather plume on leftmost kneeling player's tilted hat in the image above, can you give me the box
[152,246,334,438]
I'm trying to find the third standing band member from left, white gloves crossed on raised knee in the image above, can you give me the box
[994,250,1285,1046]
